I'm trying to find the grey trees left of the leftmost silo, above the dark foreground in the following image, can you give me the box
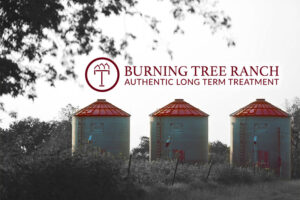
[0,117,72,163]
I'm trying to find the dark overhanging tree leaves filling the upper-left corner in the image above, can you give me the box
[0,0,135,99]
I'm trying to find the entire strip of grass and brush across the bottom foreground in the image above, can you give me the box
[0,155,300,200]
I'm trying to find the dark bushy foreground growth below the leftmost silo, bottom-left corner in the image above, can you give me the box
[0,154,143,200]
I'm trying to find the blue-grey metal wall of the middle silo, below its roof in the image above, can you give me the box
[150,117,208,162]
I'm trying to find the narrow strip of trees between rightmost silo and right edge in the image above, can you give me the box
[286,97,300,178]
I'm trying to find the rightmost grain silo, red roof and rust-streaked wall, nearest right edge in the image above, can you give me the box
[230,99,291,178]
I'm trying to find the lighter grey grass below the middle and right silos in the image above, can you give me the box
[131,161,300,200]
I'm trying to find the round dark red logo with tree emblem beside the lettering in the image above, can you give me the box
[85,57,120,92]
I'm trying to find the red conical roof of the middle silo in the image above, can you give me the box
[150,99,208,117]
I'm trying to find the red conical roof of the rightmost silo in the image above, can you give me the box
[230,99,289,117]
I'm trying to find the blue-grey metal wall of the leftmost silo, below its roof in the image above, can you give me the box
[72,117,130,157]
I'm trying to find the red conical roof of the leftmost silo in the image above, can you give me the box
[75,99,130,117]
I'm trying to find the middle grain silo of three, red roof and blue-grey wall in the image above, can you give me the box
[150,99,208,162]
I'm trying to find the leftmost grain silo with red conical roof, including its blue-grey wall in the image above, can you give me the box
[72,99,130,157]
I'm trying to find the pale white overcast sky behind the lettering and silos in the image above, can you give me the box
[0,0,300,148]
